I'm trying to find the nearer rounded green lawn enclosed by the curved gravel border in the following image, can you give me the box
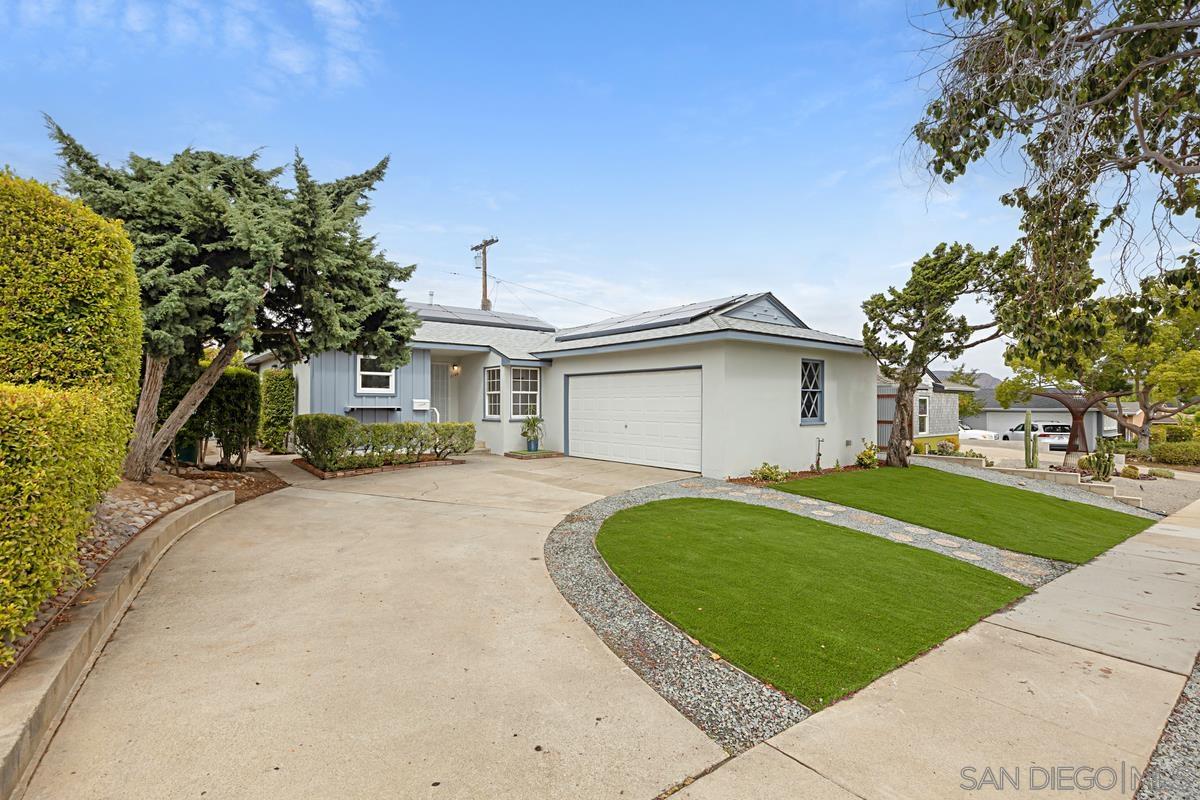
[596,499,1030,709]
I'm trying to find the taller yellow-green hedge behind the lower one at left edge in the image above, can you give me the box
[0,170,142,403]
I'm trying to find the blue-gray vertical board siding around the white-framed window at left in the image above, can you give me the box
[310,349,432,422]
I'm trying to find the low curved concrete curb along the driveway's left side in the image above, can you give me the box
[0,491,234,799]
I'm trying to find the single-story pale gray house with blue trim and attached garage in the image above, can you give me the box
[247,293,875,477]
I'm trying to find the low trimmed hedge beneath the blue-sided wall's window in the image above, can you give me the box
[295,414,475,473]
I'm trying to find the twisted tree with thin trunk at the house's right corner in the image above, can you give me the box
[863,242,1016,467]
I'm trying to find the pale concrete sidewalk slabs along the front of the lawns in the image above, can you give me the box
[676,503,1200,800]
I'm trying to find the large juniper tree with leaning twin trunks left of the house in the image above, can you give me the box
[47,118,418,481]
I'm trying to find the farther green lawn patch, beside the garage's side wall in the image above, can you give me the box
[774,467,1152,564]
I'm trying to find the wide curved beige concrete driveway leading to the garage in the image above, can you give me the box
[26,456,725,799]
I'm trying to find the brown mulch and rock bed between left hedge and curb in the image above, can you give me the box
[0,468,287,682]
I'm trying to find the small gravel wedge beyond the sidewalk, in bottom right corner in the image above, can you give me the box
[1136,661,1200,800]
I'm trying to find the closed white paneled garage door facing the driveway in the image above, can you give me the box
[566,369,701,473]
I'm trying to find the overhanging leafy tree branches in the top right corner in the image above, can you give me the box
[913,0,1200,299]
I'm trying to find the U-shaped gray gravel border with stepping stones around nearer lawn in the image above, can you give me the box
[544,477,1073,754]
